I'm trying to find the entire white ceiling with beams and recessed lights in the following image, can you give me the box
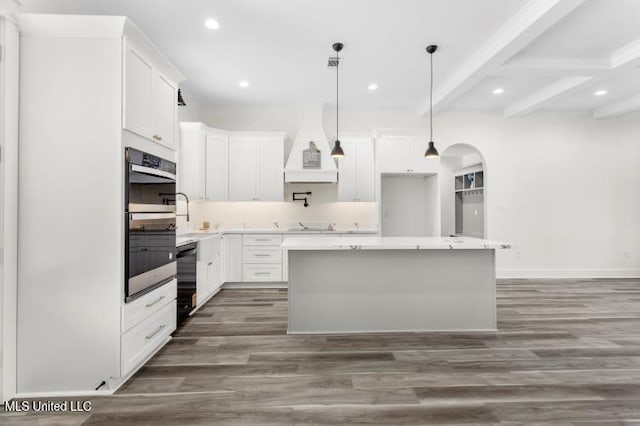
[17,0,640,117]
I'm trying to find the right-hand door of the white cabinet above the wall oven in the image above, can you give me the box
[152,74,178,149]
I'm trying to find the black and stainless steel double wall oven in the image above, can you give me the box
[125,148,177,302]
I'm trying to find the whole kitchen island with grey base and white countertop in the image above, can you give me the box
[282,237,510,334]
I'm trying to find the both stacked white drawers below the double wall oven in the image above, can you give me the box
[120,280,177,377]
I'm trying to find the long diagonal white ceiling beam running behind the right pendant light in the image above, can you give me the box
[417,0,584,116]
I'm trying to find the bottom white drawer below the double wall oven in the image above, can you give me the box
[121,303,177,376]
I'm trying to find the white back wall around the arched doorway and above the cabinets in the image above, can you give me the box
[201,108,640,277]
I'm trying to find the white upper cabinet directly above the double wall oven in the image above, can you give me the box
[122,27,181,150]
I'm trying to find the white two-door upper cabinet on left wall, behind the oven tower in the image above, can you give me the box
[177,122,229,201]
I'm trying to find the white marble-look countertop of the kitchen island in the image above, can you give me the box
[282,237,511,250]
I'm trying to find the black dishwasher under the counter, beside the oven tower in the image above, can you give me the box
[176,243,198,324]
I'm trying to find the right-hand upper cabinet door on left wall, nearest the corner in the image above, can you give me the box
[205,129,229,201]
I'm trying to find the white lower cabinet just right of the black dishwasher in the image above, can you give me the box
[196,235,222,306]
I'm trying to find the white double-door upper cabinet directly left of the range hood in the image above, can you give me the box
[229,133,284,201]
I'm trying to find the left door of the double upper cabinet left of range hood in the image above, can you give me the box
[229,138,258,201]
